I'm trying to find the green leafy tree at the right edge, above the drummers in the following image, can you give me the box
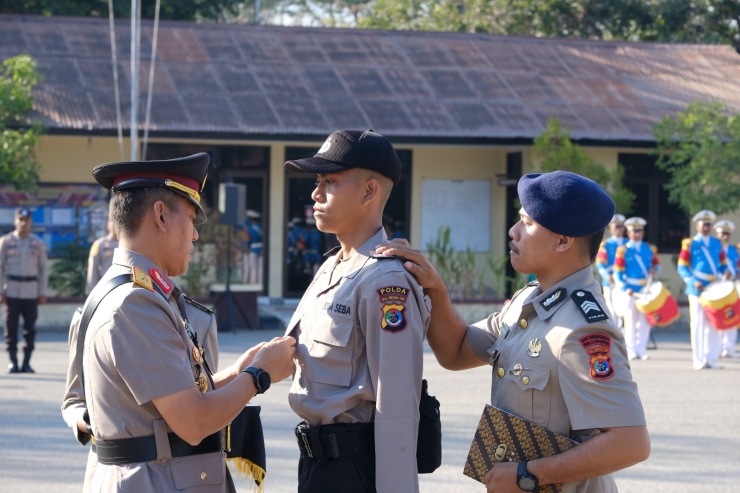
[653,101,740,215]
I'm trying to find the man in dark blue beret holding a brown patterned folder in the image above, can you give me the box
[377,171,650,493]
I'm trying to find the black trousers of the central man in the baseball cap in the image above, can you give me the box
[298,454,375,493]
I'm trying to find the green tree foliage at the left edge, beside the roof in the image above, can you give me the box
[0,55,42,190]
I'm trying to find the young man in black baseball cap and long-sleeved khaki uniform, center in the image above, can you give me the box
[285,130,431,493]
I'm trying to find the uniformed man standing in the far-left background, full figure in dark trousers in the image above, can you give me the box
[0,207,47,373]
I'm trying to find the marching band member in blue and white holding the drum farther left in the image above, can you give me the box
[614,217,660,360]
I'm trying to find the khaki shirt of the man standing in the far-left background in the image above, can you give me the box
[0,231,47,299]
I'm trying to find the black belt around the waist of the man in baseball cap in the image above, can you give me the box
[295,422,375,462]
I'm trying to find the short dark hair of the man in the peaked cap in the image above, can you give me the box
[109,187,181,238]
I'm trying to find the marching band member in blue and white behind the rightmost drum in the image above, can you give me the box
[678,210,727,370]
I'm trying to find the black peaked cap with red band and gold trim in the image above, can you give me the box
[93,152,211,224]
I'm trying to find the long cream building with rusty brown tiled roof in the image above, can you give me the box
[0,15,740,297]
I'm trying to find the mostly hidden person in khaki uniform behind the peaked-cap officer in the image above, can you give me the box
[62,296,218,492]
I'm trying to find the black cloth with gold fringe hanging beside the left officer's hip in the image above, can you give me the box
[226,406,267,486]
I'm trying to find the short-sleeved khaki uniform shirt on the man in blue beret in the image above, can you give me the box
[468,265,645,493]
